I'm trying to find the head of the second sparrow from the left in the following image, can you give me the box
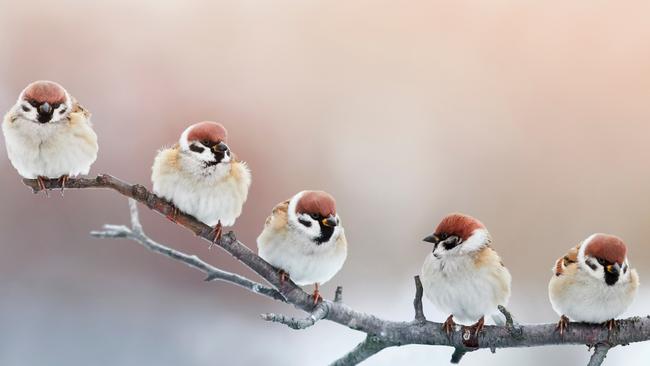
[178,121,232,168]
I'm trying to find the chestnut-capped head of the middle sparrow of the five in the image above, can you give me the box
[288,191,342,245]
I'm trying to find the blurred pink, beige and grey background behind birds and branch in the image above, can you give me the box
[0,0,650,366]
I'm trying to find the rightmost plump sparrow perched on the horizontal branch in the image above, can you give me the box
[548,234,639,334]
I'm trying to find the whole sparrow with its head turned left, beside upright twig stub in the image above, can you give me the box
[421,214,511,334]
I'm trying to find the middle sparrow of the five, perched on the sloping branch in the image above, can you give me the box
[257,191,347,304]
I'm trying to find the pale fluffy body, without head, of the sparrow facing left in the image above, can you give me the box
[421,243,511,325]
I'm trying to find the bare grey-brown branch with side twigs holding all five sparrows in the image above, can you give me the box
[23,174,650,365]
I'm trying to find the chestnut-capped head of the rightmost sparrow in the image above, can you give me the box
[578,234,630,286]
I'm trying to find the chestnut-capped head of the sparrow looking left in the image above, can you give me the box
[422,213,490,259]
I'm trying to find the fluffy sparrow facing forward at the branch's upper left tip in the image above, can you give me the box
[2,81,98,193]
